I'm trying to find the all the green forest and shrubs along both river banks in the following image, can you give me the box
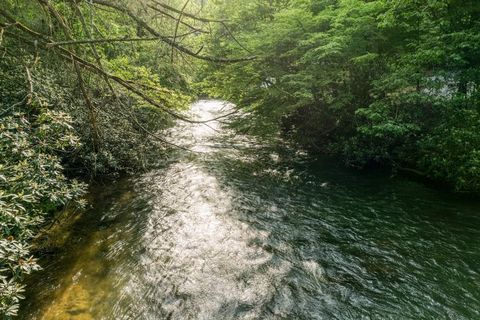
[0,0,480,316]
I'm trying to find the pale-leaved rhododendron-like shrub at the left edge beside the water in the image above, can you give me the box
[0,108,86,316]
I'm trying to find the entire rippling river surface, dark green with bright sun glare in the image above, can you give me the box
[21,101,480,319]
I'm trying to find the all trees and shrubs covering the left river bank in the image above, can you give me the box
[0,0,199,317]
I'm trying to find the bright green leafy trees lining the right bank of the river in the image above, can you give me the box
[201,0,480,192]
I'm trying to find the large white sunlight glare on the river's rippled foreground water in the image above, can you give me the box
[137,164,278,319]
